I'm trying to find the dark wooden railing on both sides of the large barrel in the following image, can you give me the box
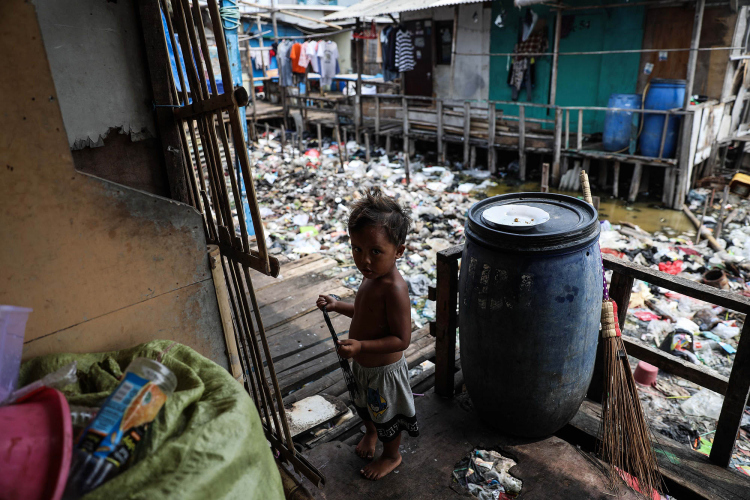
[430,245,750,467]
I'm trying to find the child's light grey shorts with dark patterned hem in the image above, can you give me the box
[352,356,419,443]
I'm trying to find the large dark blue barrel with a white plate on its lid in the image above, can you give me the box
[459,193,602,437]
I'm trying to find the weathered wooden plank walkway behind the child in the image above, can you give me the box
[251,254,444,444]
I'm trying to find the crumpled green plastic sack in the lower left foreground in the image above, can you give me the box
[19,340,284,500]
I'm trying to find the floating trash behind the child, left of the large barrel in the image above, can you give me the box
[251,135,495,328]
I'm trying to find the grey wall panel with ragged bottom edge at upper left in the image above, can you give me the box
[34,0,156,149]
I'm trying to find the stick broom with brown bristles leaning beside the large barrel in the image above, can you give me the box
[581,170,663,499]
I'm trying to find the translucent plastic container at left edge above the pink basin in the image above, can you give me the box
[0,306,32,403]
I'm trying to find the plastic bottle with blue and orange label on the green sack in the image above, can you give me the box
[63,358,177,500]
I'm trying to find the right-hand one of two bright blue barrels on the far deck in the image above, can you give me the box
[638,78,685,158]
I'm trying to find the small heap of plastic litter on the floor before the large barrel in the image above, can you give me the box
[453,450,523,500]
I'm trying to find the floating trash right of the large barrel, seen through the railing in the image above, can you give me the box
[600,190,750,475]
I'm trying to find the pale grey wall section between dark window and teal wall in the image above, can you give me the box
[401,3,492,99]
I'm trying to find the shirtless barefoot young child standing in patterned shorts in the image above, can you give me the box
[317,188,419,480]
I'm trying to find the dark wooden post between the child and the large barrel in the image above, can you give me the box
[435,253,458,397]
